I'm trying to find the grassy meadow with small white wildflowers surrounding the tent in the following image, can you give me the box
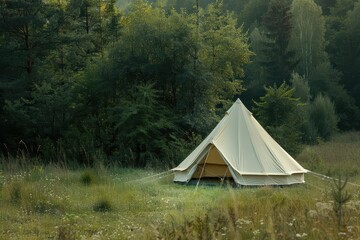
[0,132,360,239]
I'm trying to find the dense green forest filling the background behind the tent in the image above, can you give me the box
[0,0,360,167]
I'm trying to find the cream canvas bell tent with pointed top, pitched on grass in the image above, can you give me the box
[172,99,307,186]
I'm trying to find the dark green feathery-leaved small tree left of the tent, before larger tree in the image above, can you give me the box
[109,84,174,167]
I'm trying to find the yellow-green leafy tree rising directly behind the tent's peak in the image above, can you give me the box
[199,1,252,109]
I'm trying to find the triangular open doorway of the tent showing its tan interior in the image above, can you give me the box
[191,145,234,185]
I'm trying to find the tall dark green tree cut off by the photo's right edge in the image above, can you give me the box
[327,0,360,130]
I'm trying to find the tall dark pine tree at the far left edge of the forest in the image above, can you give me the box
[0,0,63,150]
